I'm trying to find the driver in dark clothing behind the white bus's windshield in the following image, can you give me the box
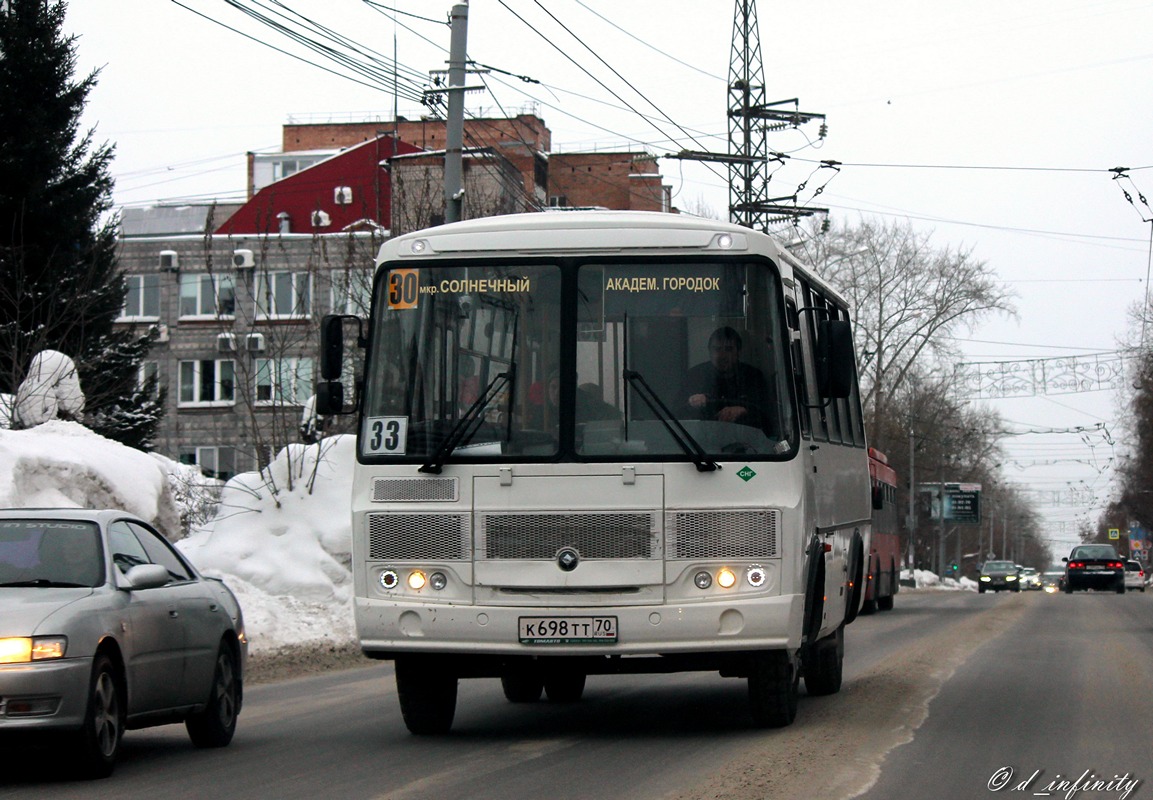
[683,325,775,436]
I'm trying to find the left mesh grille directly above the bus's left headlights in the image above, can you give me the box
[368,514,472,561]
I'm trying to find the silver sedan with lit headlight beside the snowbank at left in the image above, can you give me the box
[0,508,248,777]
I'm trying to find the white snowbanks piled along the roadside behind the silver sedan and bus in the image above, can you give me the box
[0,421,977,654]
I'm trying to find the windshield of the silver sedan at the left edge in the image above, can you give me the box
[0,520,104,587]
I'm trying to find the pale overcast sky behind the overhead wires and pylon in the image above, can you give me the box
[60,0,1153,556]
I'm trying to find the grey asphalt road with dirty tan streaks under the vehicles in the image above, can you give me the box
[0,591,1153,800]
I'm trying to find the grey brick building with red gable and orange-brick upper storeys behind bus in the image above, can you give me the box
[119,115,672,478]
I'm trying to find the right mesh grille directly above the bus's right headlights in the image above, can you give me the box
[665,508,781,559]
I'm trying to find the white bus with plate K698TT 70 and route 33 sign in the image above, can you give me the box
[317,211,871,733]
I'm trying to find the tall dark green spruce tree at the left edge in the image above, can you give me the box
[0,0,163,450]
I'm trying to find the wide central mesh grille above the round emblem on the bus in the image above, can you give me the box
[476,512,661,560]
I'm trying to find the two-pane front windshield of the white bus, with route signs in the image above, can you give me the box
[360,259,796,465]
